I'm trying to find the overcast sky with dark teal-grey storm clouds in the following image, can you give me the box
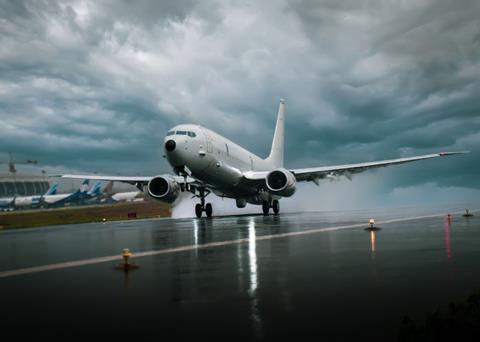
[0,0,480,210]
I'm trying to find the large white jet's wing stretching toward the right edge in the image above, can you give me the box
[244,151,468,183]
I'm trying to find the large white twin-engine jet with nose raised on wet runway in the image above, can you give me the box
[56,99,468,217]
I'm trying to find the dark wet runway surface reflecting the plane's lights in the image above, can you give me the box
[0,211,480,341]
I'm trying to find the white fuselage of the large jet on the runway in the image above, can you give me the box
[164,124,273,203]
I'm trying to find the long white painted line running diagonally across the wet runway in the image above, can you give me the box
[0,209,472,278]
